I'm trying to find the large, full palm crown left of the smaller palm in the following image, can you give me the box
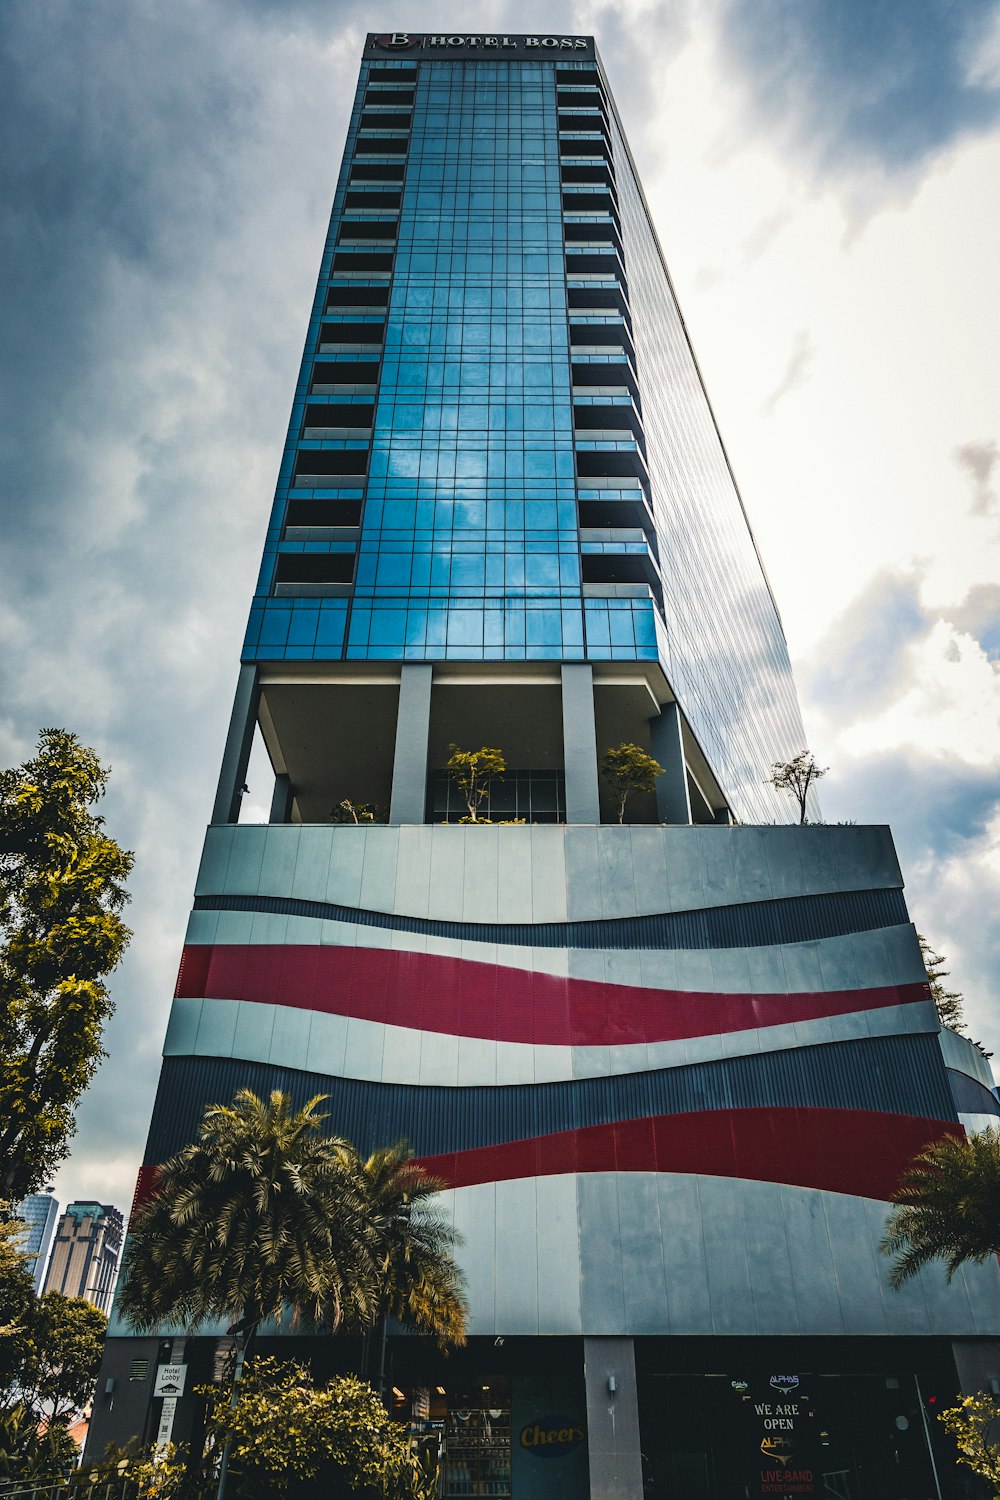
[120,1089,378,1331]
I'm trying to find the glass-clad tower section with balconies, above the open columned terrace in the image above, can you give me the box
[244,39,804,821]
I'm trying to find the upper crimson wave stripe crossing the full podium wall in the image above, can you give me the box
[174,944,930,1047]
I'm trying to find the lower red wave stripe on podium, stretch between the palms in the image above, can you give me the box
[421,1109,966,1200]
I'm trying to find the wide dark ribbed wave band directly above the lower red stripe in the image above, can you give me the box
[145,1035,957,1163]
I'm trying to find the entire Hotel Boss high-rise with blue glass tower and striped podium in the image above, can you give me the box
[91,33,1000,1500]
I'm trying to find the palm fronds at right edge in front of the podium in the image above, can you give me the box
[879,1127,1000,1289]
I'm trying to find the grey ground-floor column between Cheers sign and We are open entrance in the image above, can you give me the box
[583,1338,642,1500]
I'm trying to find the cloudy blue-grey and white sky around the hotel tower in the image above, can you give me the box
[0,0,1000,1208]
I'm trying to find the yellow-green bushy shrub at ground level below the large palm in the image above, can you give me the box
[199,1358,436,1500]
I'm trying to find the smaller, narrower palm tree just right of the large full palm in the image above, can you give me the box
[357,1140,468,1391]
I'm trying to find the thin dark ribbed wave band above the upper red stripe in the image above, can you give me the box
[195,888,910,948]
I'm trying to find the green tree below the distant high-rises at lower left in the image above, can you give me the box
[0,1292,108,1424]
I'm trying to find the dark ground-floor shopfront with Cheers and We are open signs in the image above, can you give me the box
[91,1337,1000,1500]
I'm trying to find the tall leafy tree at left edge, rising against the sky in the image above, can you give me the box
[0,729,132,1202]
